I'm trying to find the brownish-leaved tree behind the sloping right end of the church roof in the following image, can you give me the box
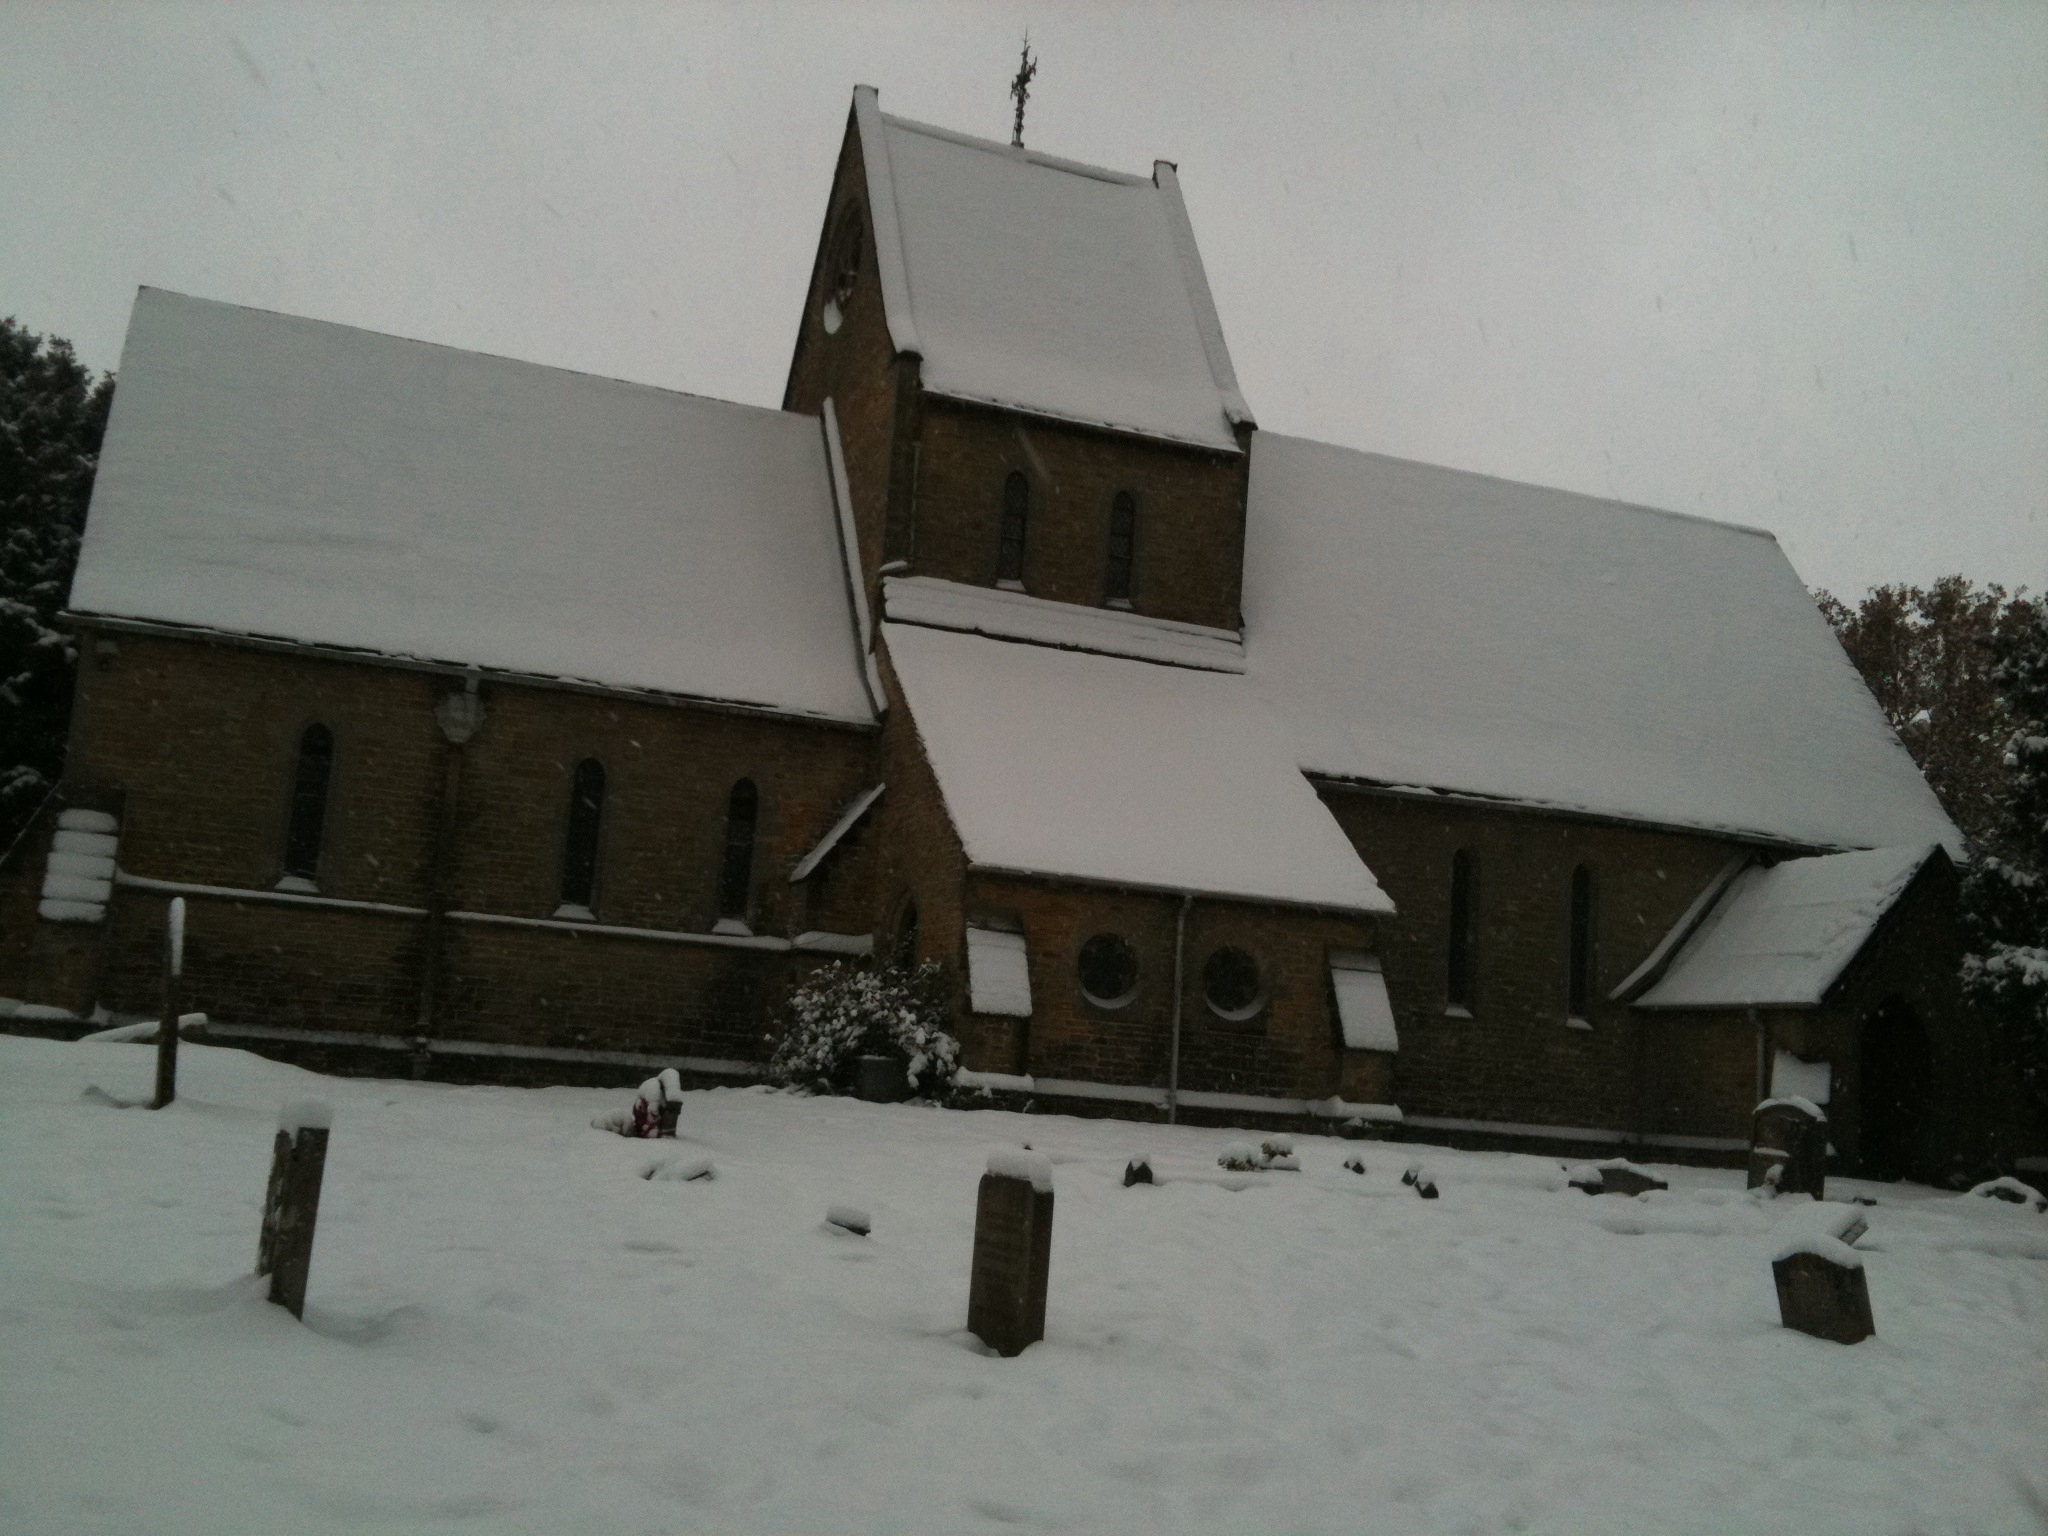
[1815,575,2042,868]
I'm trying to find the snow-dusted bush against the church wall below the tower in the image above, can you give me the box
[768,961,961,1094]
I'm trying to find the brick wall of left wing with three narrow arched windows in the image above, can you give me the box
[0,635,879,1055]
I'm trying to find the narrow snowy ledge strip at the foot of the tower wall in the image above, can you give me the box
[883,575,1245,672]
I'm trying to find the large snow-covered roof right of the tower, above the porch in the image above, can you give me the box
[1243,432,1962,852]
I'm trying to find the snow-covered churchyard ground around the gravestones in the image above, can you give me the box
[0,1036,2048,1536]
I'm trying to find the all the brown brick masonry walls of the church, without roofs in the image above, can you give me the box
[0,119,2017,1171]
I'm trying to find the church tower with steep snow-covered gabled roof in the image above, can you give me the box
[782,86,1255,631]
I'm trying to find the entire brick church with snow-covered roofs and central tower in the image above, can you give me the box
[0,88,1991,1174]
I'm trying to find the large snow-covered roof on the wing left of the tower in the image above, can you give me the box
[72,289,872,721]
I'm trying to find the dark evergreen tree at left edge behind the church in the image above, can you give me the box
[0,317,115,848]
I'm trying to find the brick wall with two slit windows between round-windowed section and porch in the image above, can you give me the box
[1323,786,1755,1135]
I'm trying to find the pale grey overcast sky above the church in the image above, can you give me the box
[0,0,2048,594]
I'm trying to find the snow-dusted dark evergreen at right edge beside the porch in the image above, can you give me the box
[1962,604,2048,1110]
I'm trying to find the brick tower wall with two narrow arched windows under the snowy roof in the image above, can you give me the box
[911,395,1249,629]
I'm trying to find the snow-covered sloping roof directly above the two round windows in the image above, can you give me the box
[883,623,1393,911]
